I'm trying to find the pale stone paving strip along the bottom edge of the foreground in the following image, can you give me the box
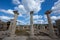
[3,36,60,40]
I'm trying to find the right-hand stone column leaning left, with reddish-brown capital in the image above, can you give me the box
[45,10,56,38]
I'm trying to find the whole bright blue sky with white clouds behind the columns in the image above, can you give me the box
[0,0,60,25]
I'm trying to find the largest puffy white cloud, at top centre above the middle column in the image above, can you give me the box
[22,0,44,12]
